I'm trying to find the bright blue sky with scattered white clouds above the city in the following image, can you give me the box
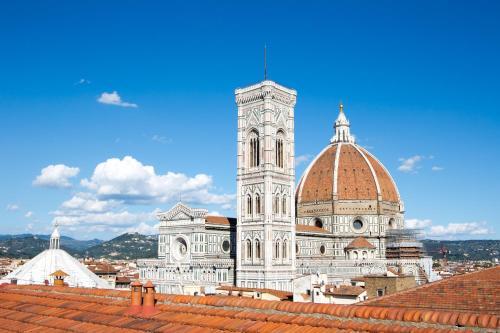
[0,1,500,239]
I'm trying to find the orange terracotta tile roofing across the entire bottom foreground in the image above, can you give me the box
[0,267,500,333]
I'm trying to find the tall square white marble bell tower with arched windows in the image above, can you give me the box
[235,80,297,291]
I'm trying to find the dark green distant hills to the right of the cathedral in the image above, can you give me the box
[422,239,500,261]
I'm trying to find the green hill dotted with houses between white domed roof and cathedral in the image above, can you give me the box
[84,233,158,259]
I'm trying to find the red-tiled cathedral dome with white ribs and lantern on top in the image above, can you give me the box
[296,105,400,205]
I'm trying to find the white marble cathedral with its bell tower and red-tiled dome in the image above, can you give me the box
[138,80,433,294]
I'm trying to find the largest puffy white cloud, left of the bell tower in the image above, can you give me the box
[81,156,235,205]
